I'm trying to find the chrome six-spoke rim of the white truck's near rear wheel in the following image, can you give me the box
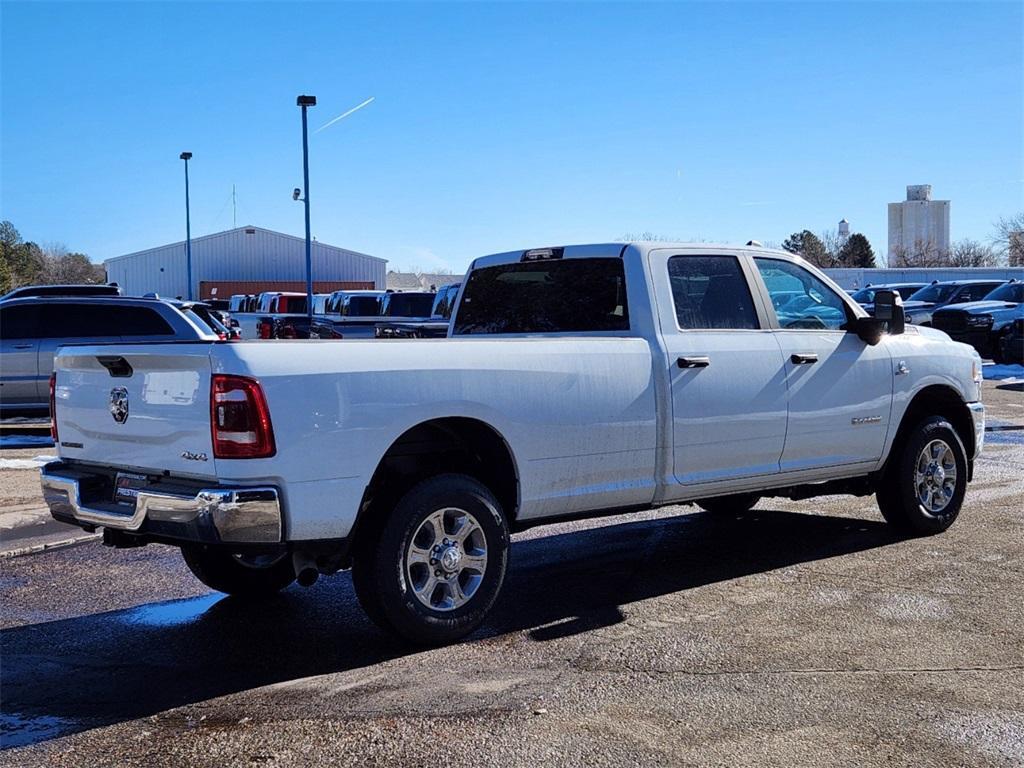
[406,507,487,610]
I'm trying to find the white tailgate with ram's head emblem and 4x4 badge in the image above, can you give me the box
[54,343,216,477]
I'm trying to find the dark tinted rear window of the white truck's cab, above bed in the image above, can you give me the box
[454,258,630,335]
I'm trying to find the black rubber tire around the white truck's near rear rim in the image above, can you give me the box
[352,474,509,645]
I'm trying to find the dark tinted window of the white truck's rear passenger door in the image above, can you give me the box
[669,256,760,331]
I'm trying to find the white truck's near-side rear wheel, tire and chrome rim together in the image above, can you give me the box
[352,474,509,645]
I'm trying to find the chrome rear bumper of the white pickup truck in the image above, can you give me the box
[42,462,283,544]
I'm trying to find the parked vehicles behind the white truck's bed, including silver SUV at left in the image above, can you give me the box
[0,284,459,411]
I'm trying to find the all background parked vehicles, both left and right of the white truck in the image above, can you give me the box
[0,272,1024,409]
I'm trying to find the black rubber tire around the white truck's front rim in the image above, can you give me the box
[876,416,967,536]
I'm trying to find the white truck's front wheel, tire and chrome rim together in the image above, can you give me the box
[876,416,967,536]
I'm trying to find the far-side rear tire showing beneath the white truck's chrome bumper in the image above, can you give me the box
[181,545,295,598]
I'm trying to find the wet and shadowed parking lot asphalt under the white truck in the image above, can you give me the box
[0,383,1024,767]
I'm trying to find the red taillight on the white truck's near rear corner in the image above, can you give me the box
[210,374,275,459]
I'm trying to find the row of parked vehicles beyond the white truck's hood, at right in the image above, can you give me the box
[852,280,1024,362]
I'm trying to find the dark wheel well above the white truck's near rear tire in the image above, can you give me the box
[352,417,519,552]
